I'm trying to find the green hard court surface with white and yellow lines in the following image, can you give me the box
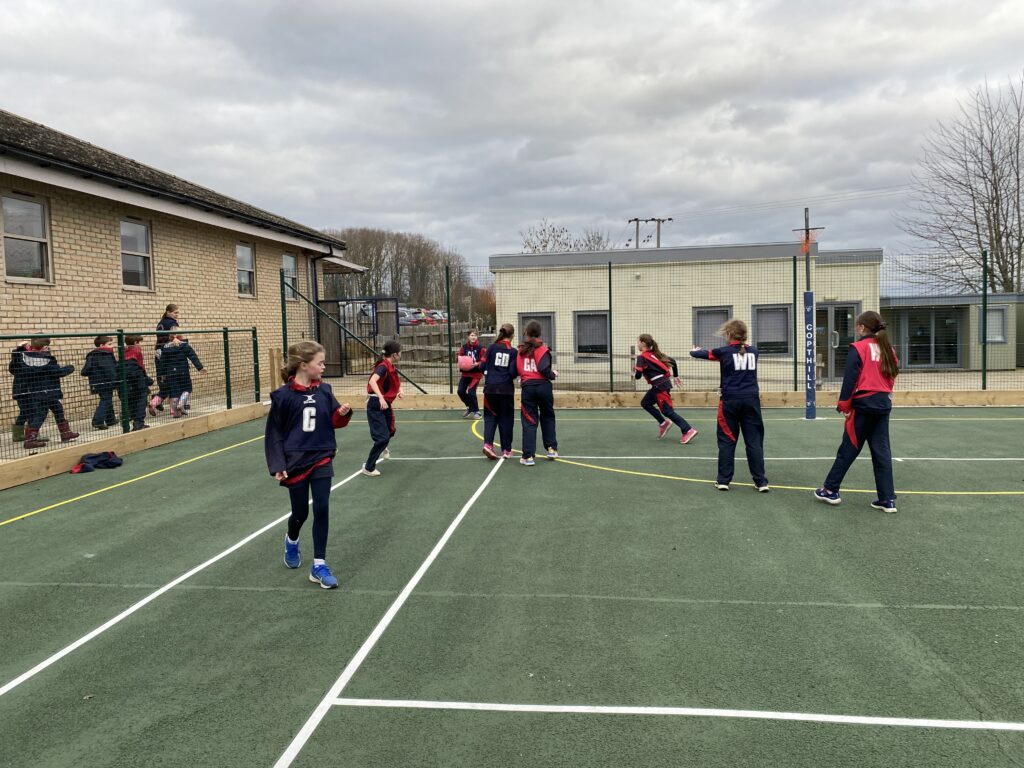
[0,409,1024,768]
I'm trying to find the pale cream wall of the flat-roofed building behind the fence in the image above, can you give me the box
[495,259,879,389]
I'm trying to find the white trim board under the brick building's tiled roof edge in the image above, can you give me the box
[0,155,352,260]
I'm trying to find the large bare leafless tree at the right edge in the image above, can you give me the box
[900,75,1024,292]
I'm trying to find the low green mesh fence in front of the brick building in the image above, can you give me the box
[0,329,258,461]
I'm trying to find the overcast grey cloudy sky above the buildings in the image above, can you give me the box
[0,0,1024,263]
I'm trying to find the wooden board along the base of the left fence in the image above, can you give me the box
[0,402,267,490]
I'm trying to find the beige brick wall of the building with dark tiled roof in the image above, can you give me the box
[0,174,319,392]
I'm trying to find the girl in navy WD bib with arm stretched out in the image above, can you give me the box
[690,319,771,493]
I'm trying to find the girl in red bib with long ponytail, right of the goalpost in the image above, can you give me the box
[814,311,899,512]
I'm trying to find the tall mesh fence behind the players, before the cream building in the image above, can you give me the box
[313,243,1024,399]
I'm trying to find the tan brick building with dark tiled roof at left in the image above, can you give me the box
[0,111,362,378]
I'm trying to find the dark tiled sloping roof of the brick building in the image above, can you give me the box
[0,110,345,250]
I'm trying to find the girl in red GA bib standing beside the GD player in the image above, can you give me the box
[516,321,558,467]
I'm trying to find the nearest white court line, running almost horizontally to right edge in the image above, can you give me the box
[331,698,1024,731]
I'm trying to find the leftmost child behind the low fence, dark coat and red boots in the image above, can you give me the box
[11,336,79,449]
